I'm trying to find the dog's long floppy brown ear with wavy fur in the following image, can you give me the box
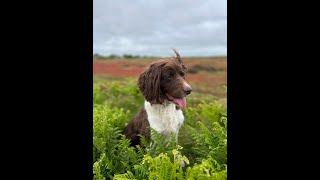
[138,63,163,104]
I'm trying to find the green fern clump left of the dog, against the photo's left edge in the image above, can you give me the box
[93,104,142,179]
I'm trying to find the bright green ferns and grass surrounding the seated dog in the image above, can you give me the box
[93,78,227,180]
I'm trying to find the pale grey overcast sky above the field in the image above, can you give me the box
[93,0,227,57]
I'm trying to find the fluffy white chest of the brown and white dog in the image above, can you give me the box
[144,101,184,135]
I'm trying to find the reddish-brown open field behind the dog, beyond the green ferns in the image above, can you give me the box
[93,57,227,98]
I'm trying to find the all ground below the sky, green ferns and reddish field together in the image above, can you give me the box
[93,57,227,180]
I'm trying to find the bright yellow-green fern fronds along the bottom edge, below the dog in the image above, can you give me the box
[114,148,227,180]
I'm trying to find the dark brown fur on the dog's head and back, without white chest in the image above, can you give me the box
[123,49,192,146]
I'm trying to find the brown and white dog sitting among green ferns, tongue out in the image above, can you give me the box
[123,49,192,146]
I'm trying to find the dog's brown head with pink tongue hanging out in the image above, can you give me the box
[138,49,192,108]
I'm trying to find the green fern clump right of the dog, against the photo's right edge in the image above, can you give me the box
[179,102,227,164]
